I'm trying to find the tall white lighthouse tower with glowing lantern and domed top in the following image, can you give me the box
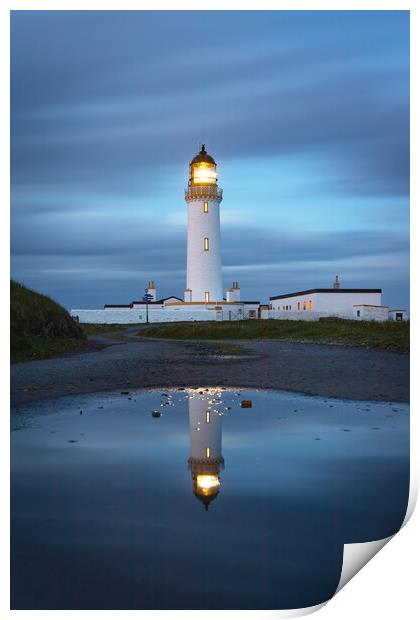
[184,144,223,303]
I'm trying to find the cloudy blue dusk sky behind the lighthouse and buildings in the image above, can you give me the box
[11,11,409,309]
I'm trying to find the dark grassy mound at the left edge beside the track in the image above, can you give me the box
[10,280,87,362]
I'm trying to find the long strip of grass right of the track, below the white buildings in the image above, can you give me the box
[138,319,410,352]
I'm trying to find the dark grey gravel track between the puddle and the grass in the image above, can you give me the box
[11,328,409,406]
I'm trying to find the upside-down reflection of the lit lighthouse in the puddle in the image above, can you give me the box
[188,390,224,510]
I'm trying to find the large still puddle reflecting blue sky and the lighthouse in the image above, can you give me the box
[12,390,409,609]
